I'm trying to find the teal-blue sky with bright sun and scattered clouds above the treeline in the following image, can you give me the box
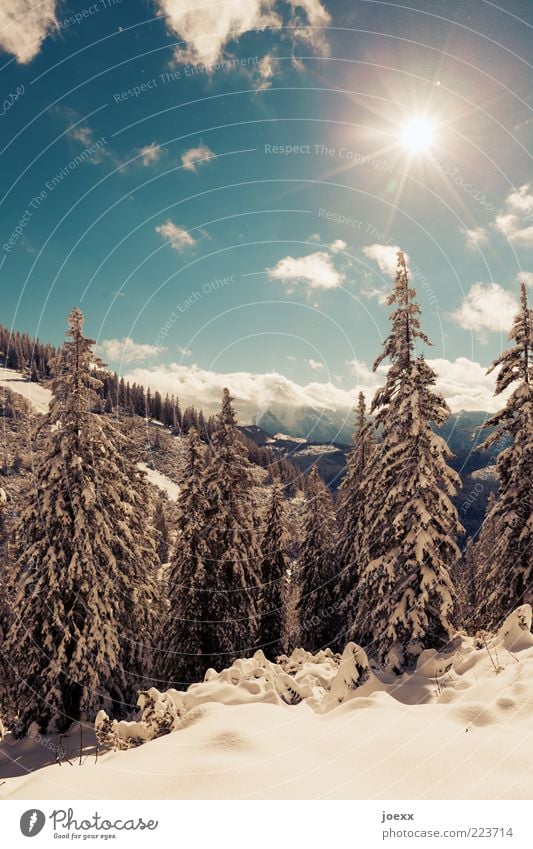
[0,0,533,418]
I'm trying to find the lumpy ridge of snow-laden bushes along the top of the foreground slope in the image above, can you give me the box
[95,605,533,749]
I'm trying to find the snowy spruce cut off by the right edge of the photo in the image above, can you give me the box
[479,282,533,627]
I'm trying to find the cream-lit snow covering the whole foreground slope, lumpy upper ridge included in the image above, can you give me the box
[4,605,533,799]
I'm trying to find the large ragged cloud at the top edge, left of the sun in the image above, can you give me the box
[154,0,331,66]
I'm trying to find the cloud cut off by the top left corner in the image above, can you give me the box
[0,0,57,64]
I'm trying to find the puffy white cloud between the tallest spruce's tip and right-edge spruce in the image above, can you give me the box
[451,283,517,339]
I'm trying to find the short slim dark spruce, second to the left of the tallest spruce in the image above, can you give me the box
[296,466,340,651]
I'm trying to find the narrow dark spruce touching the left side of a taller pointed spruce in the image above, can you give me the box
[160,427,212,688]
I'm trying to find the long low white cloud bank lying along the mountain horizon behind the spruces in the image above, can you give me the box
[124,357,503,421]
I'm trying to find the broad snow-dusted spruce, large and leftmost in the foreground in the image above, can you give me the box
[8,309,157,735]
